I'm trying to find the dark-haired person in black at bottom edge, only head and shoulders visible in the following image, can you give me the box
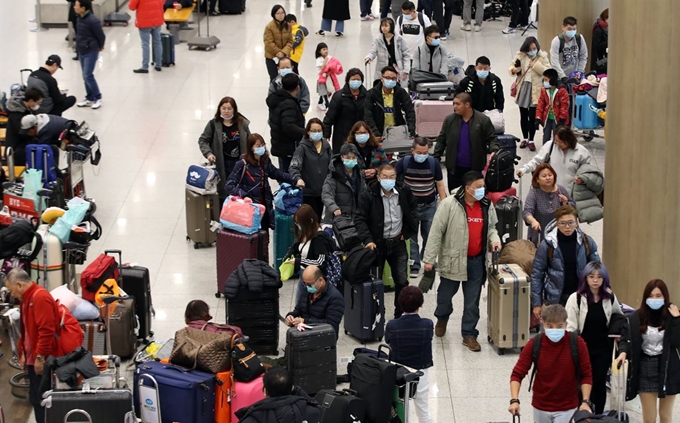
[236,366,321,423]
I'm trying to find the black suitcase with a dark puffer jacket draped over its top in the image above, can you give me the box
[225,288,279,355]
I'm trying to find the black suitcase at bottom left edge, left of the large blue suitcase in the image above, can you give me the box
[43,389,136,423]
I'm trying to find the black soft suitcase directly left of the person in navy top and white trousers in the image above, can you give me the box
[349,345,397,423]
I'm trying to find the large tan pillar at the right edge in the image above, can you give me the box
[604,0,680,307]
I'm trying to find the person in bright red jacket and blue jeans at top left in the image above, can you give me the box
[130,0,165,73]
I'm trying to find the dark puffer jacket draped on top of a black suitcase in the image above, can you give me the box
[224,259,283,298]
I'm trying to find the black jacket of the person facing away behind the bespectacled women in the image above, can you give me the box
[267,88,305,157]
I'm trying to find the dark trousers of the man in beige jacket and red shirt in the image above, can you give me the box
[434,254,484,338]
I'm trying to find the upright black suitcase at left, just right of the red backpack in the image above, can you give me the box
[121,266,155,339]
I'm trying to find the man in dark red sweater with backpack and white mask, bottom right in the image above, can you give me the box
[508,304,593,423]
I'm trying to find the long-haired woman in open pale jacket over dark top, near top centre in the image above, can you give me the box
[365,18,411,87]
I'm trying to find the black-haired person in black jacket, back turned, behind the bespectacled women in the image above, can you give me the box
[267,73,305,172]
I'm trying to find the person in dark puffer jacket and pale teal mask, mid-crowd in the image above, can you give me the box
[321,144,366,221]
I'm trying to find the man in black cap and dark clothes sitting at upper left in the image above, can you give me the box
[26,54,76,116]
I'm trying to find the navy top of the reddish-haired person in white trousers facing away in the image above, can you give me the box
[385,314,434,369]
